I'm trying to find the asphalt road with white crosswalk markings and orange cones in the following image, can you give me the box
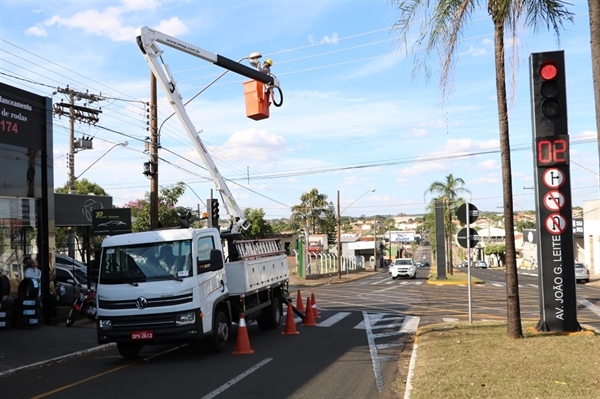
[1,268,600,399]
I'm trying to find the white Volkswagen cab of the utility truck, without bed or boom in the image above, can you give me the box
[97,229,231,357]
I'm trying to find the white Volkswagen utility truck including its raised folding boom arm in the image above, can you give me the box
[96,27,289,358]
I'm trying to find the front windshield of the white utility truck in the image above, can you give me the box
[100,240,193,284]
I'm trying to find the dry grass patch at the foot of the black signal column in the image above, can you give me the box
[410,323,600,399]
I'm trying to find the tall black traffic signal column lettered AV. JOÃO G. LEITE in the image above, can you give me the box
[530,51,581,332]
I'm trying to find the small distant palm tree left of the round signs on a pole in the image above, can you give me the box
[423,173,471,275]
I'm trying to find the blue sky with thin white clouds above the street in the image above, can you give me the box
[0,0,600,219]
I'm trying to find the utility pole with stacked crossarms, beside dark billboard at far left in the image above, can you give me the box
[54,86,104,258]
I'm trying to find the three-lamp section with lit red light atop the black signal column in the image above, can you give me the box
[530,51,568,138]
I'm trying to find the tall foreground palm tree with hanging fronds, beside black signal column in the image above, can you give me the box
[392,0,576,338]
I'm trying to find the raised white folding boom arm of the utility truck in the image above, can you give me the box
[136,26,279,233]
